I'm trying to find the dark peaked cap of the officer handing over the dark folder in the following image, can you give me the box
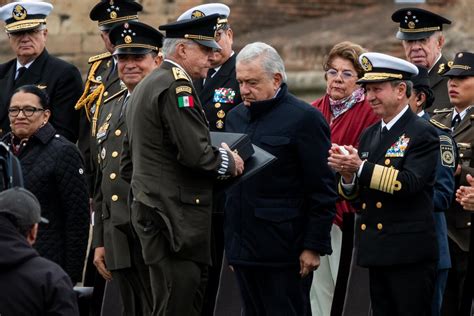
[159,14,221,49]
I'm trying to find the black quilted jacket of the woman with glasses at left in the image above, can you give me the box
[3,123,89,283]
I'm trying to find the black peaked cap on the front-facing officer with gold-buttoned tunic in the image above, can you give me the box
[109,21,163,55]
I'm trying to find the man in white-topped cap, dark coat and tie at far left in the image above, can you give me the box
[0,1,82,142]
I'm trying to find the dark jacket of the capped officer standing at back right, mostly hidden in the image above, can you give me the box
[425,56,451,115]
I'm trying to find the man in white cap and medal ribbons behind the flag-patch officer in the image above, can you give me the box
[178,3,242,131]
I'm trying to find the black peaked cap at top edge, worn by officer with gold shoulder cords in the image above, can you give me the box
[89,0,143,31]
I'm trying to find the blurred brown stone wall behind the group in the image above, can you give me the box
[0,0,466,97]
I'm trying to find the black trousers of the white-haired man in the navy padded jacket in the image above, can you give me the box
[234,266,313,316]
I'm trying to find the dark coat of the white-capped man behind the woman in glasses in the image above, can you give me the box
[0,49,82,143]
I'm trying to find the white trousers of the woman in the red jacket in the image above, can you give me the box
[310,224,342,316]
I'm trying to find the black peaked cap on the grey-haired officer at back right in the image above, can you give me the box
[392,8,451,41]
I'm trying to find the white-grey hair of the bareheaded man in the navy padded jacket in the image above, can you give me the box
[236,42,287,82]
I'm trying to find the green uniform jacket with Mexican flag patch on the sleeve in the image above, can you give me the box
[121,60,234,264]
